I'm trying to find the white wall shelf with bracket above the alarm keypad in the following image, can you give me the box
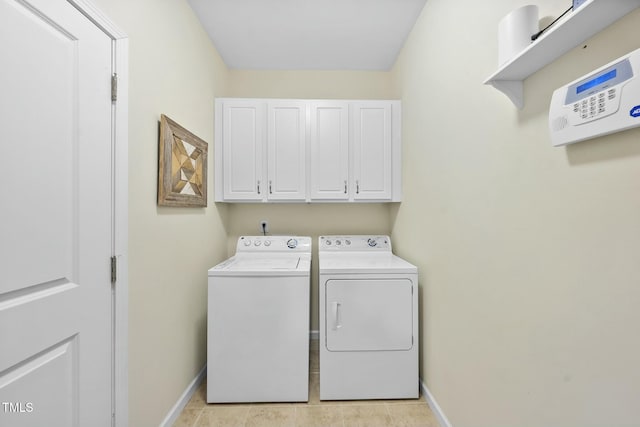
[484,0,640,109]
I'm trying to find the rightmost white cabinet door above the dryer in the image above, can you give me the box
[350,101,392,200]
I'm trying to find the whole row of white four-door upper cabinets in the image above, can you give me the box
[215,98,402,202]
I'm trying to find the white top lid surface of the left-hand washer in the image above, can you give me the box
[209,253,311,276]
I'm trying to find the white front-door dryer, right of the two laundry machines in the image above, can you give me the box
[318,236,419,400]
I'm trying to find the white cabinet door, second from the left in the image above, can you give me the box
[267,101,307,201]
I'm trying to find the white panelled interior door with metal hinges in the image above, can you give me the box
[0,0,113,427]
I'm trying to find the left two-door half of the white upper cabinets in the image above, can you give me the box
[215,99,307,202]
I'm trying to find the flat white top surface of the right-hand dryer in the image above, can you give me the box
[319,252,418,274]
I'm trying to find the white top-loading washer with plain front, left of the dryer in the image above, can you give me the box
[207,236,311,402]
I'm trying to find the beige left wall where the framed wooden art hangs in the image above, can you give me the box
[87,0,227,427]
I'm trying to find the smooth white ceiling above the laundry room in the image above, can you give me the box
[188,0,426,71]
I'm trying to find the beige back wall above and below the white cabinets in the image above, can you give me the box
[227,70,394,331]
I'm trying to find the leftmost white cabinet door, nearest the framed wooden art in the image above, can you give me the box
[222,100,266,201]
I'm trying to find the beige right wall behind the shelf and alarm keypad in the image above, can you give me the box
[391,0,640,427]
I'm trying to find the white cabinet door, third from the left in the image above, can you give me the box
[310,101,349,200]
